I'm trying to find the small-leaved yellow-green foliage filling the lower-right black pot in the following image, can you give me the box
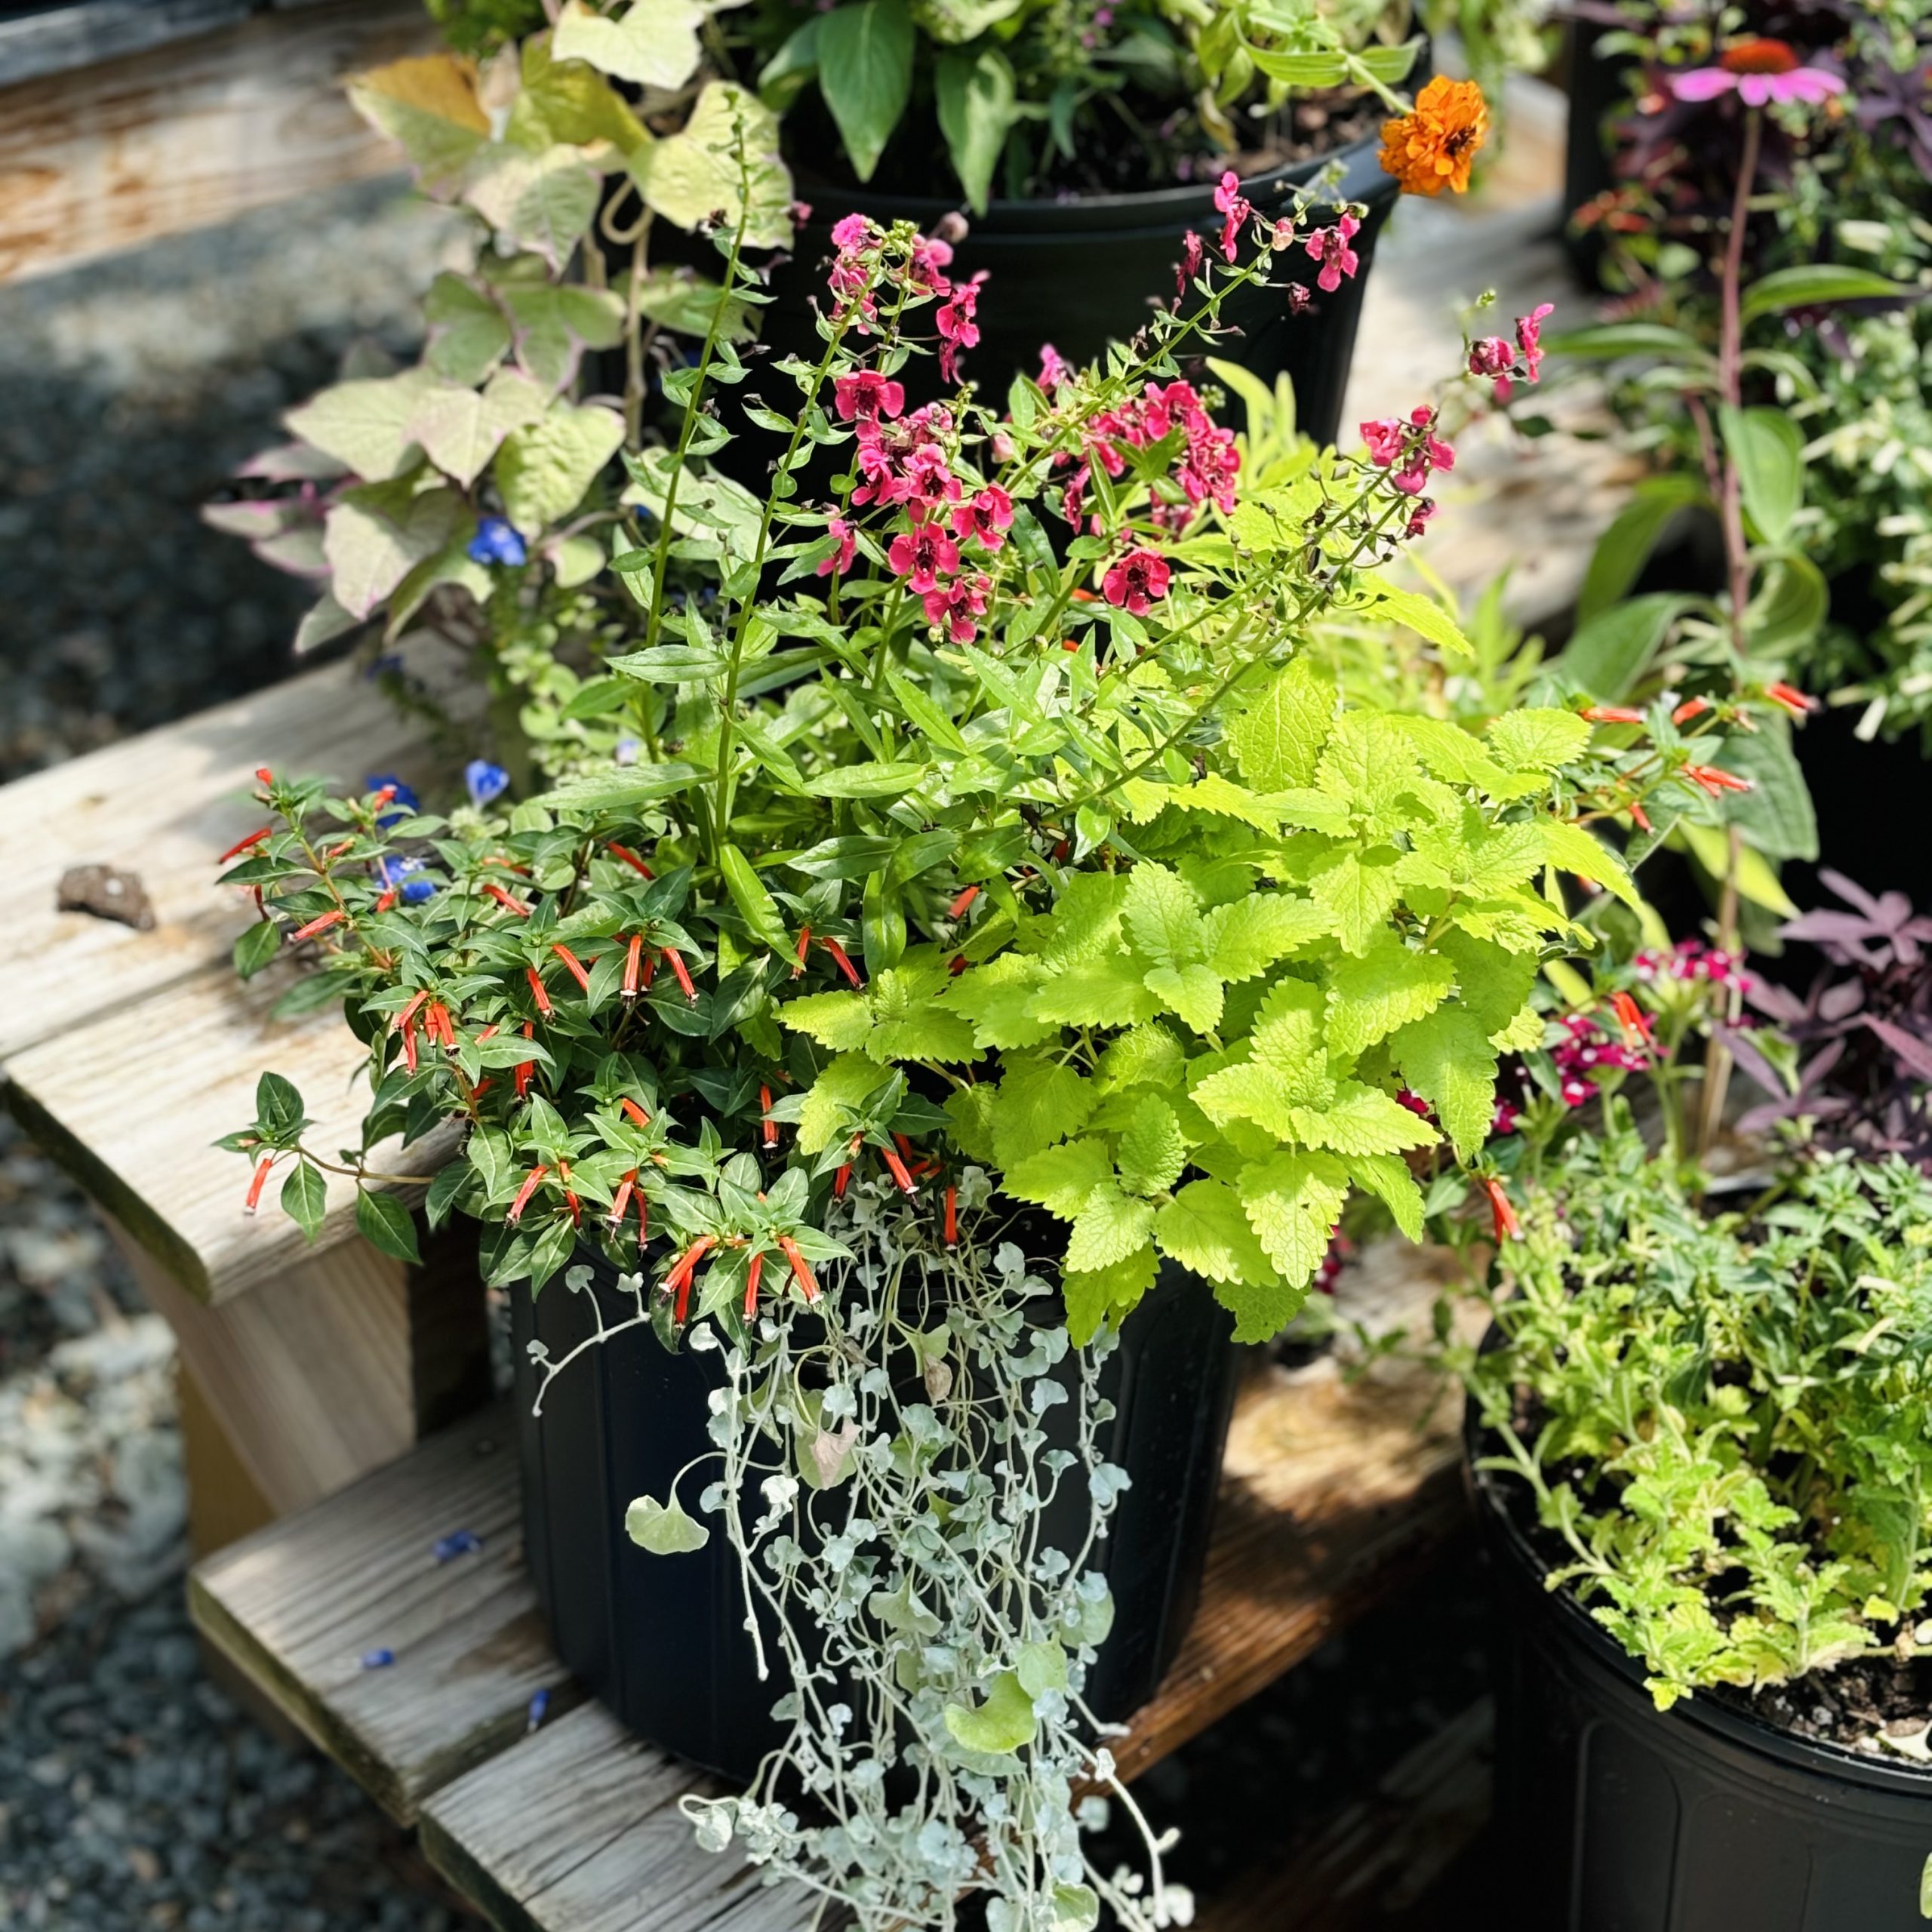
[1463,1101,1932,1706]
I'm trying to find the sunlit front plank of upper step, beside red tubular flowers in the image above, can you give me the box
[6,946,463,1302]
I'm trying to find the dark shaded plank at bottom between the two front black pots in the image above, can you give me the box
[1194,1698,1495,1932]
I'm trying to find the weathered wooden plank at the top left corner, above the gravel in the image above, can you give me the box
[0,0,437,280]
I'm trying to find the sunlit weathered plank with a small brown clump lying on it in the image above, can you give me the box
[0,649,481,1091]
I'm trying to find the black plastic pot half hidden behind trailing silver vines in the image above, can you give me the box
[512,1250,1238,1783]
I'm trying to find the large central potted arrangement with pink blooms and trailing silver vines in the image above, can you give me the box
[211,116,1697,1926]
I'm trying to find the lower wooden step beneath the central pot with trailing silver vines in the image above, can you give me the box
[189,1244,1463,1932]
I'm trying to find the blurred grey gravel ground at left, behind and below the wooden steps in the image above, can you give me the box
[0,183,477,1932]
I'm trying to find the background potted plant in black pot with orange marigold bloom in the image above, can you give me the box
[343,0,1487,454]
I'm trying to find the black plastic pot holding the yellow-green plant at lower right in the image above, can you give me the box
[1470,1418,1932,1932]
